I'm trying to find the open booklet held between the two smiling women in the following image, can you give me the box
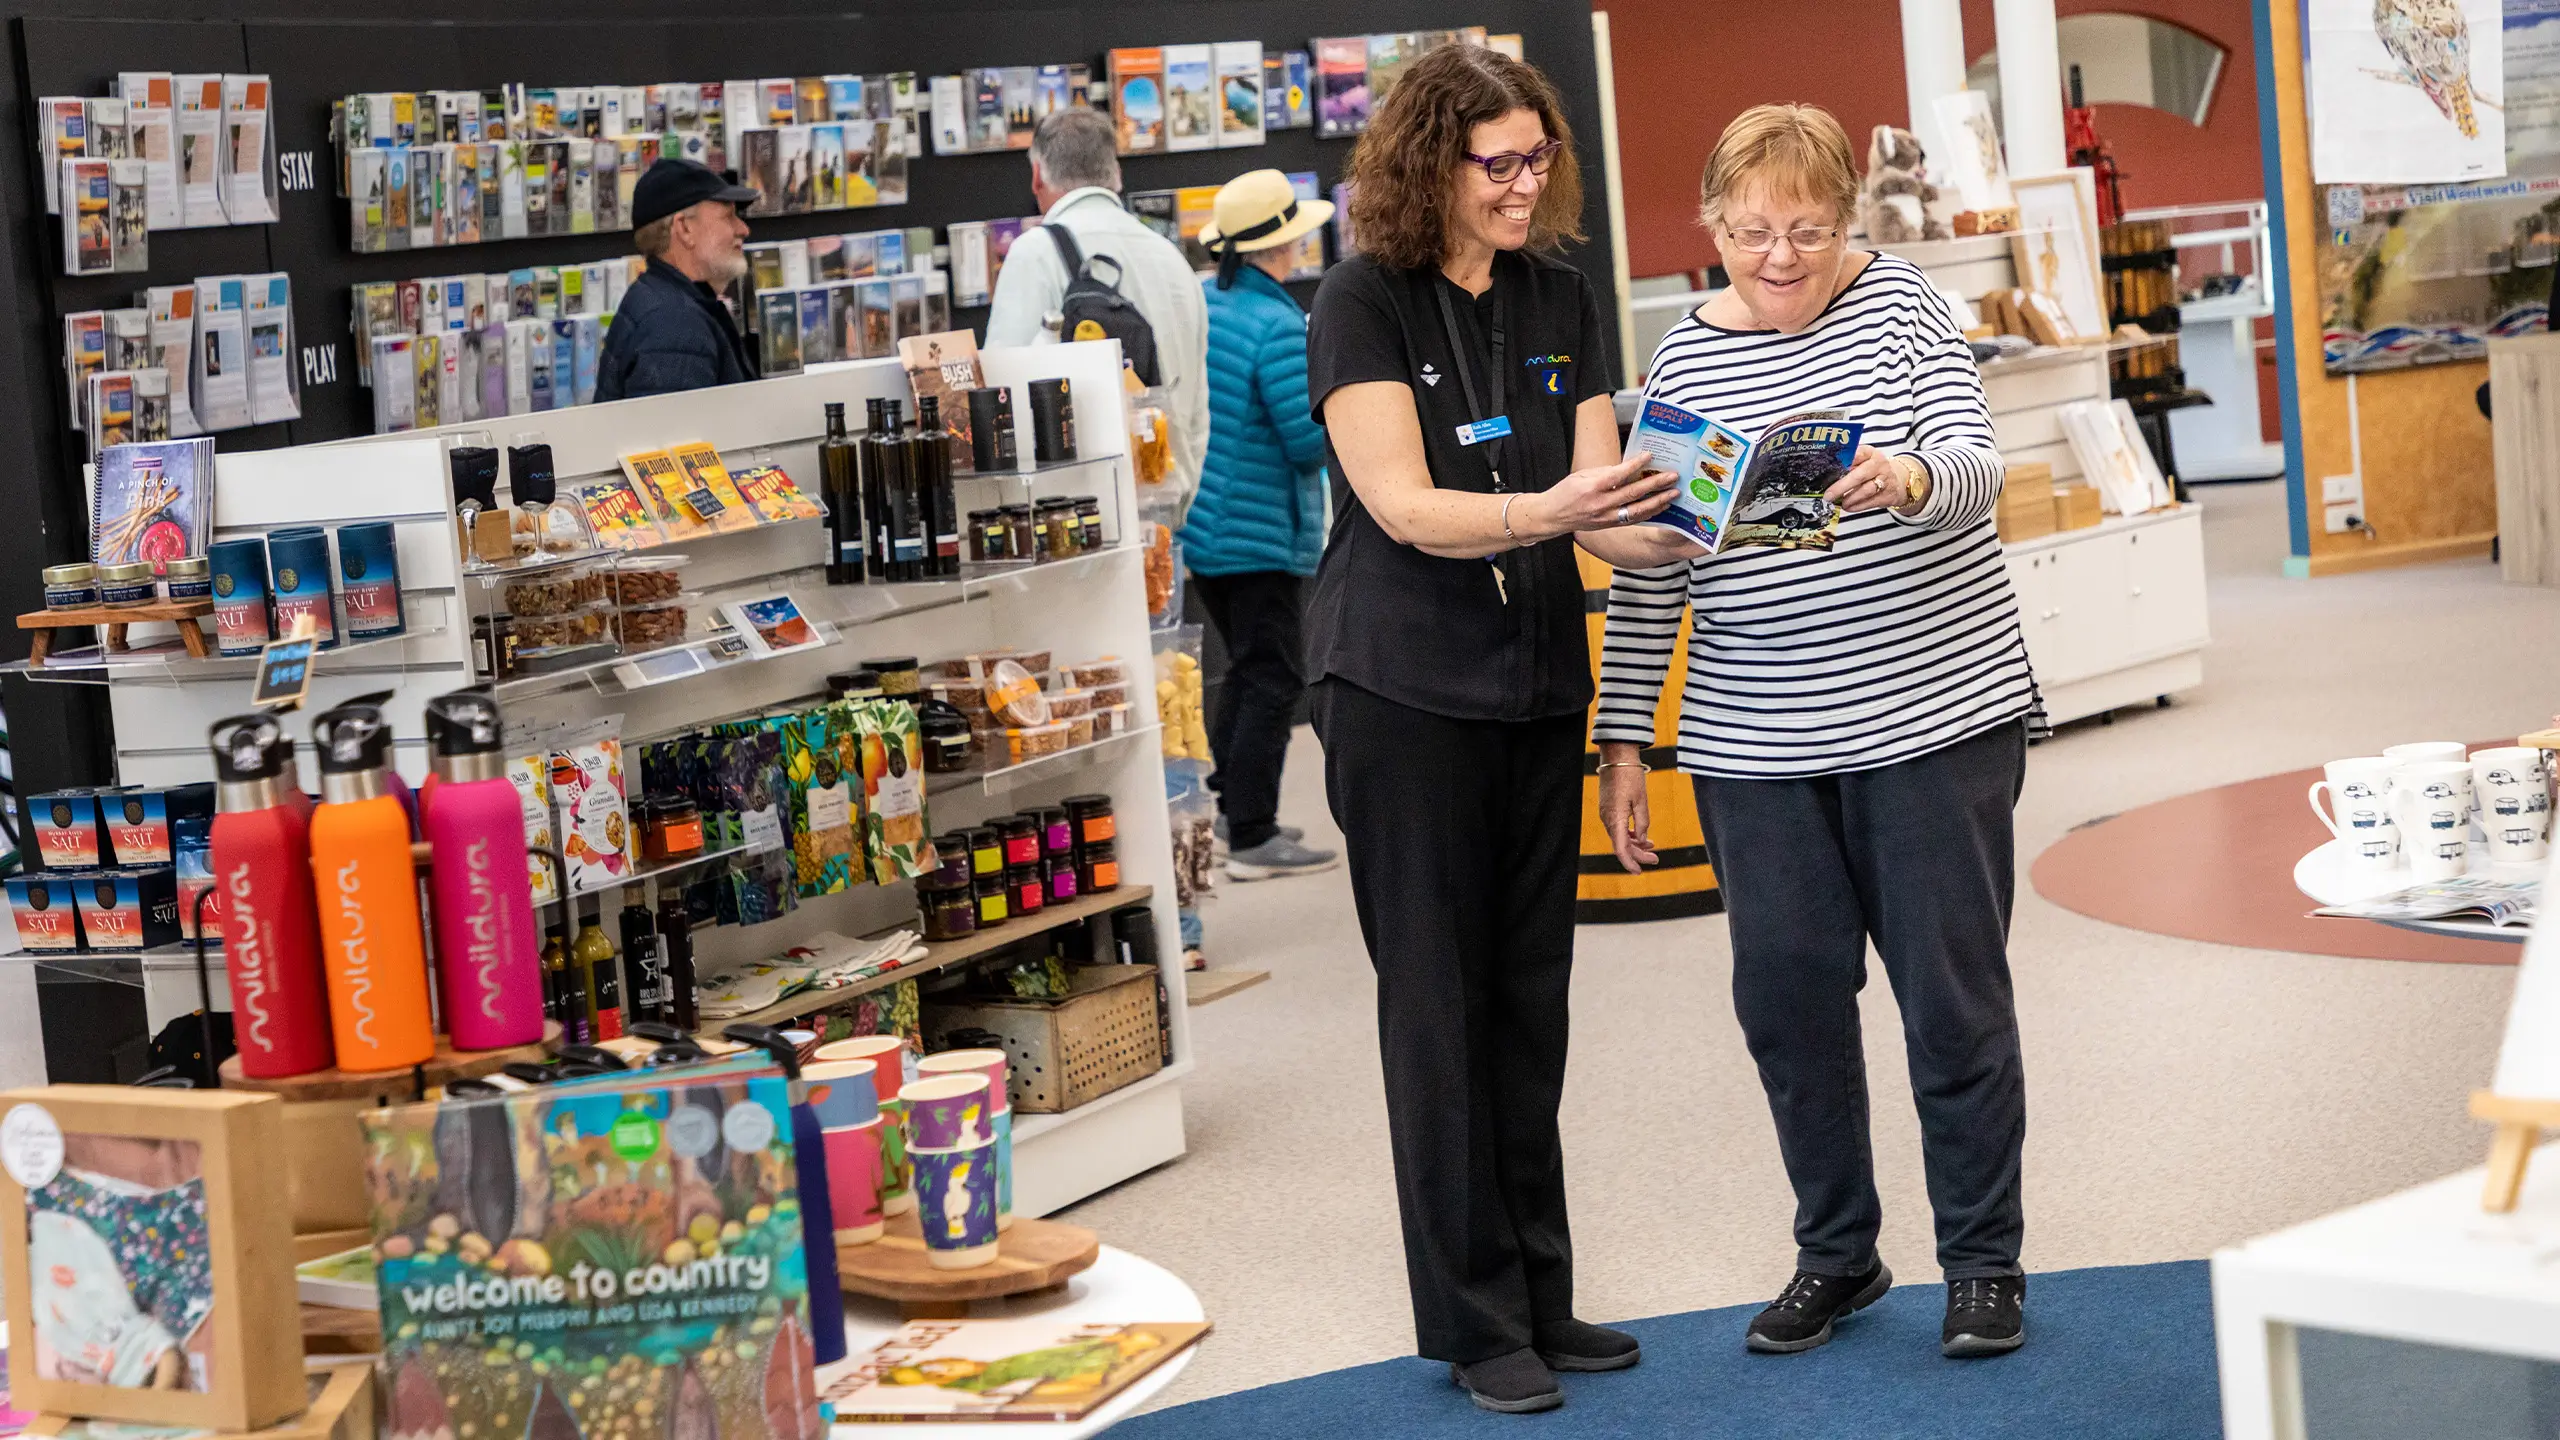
[1626,395,1866,556]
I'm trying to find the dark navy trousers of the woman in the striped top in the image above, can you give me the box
[1697,723,2028,1281]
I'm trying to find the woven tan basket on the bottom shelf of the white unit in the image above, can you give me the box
[924,966,1165,1115]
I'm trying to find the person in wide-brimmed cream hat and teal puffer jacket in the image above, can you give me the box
[1183,169,1336,879]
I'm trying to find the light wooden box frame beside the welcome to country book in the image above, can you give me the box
[0,1084,310,1432]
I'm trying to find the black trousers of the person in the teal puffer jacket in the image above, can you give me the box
[1190,571,1306,851]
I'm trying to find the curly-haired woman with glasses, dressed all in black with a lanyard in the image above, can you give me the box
[1308,46,1669,1412]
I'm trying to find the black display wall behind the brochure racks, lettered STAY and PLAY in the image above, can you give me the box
[0,0,1615,794]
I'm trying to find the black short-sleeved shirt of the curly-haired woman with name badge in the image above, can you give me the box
[1306,251,1610,720]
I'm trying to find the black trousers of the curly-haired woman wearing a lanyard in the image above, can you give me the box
[1316,679,1585,1363]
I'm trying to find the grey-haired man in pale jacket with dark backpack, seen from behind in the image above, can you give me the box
[986,108,1208,502]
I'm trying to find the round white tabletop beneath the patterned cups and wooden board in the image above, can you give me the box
[817,1245,1208,1440]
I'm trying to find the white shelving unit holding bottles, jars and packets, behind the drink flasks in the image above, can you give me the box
[64,341,1193,1215]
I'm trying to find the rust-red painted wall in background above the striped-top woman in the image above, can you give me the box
[1592,0,2266,274]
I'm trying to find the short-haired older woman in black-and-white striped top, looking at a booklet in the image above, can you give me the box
[1592,105,2038,1355]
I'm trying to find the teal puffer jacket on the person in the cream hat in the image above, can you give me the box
[1183,266,1324,574]
